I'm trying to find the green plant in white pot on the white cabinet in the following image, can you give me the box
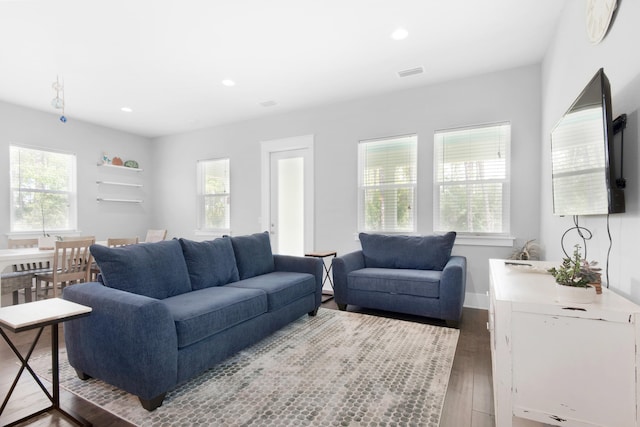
[548,245,600,304]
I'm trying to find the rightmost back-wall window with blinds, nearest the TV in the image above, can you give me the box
[433,123,511,235]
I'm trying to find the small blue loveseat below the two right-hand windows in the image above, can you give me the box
[333,232,467,327]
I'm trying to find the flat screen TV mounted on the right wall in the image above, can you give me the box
[551,68,625,216]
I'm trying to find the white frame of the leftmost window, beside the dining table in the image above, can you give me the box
[9,143,78,235]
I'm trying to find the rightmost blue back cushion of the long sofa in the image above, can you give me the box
[231,231,274,279]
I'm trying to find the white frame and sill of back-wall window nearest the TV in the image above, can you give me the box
[433,121,513,239]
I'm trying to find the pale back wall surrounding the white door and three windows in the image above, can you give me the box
[152,66,541,305]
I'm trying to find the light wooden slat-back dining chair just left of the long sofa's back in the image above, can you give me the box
[36,237,96,298]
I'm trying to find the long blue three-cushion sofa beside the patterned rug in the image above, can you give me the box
[63,233,322,411]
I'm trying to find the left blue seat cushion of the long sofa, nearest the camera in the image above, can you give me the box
[162,286,267,348]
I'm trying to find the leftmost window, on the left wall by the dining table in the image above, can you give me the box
[9,145,77,234]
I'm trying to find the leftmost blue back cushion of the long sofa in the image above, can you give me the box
[91,240,191,299]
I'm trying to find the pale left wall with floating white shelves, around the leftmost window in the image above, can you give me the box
[0,102,153,247]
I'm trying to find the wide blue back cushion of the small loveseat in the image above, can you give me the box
[360,231,456,270]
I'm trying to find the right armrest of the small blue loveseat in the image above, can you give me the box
[440,255,467,322]
